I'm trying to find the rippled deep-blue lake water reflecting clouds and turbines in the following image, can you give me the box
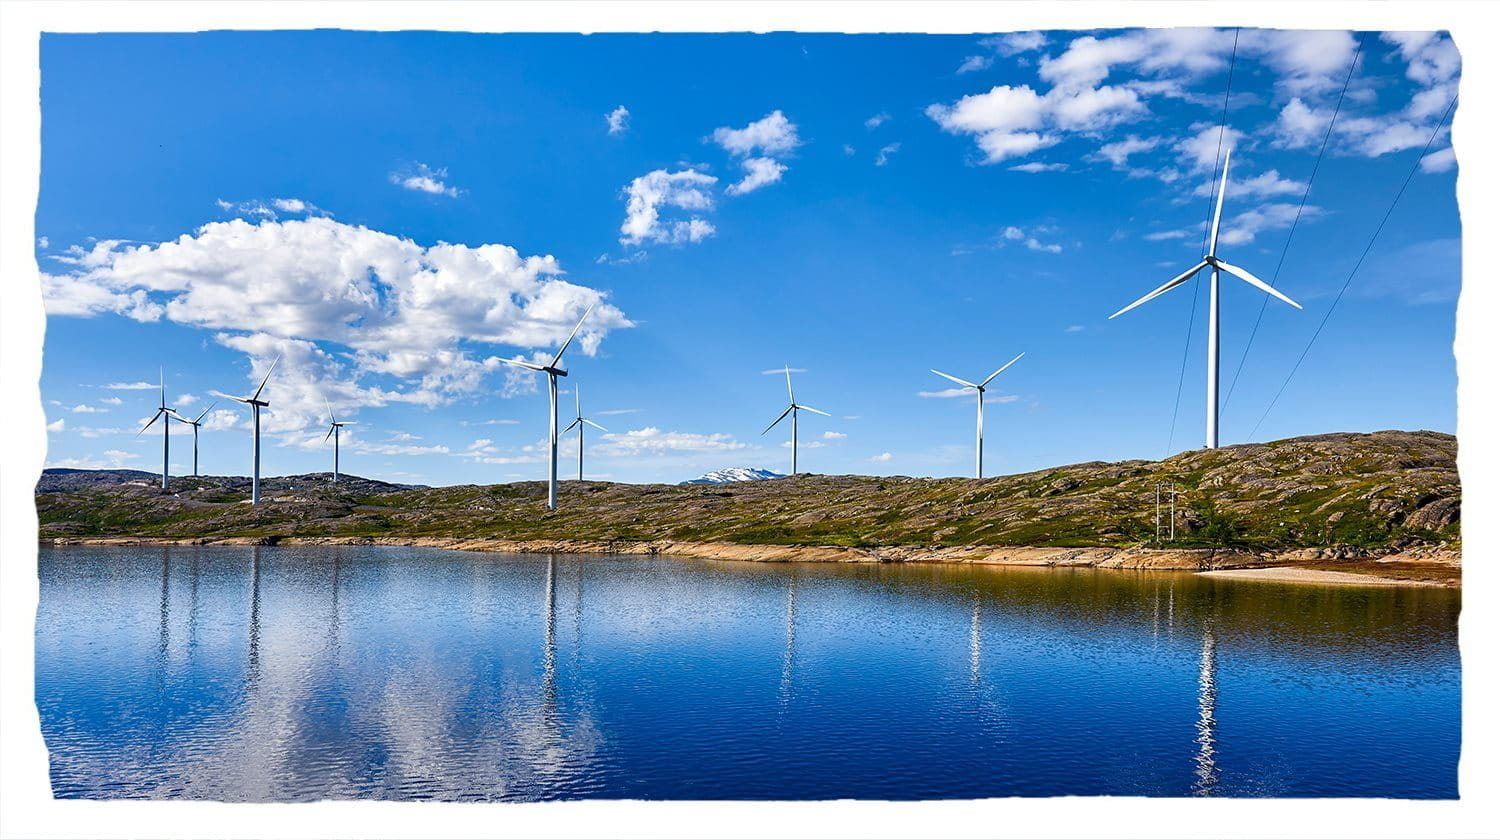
[36,548,1460,801]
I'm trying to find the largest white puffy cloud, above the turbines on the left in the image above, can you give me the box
[42,218,630,441]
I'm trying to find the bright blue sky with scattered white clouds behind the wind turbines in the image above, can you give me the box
[36,30,1460,483]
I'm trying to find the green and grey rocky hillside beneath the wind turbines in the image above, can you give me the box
[36,432,1460,551]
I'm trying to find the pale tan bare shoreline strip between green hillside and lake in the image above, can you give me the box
[41,536,1463,588]
